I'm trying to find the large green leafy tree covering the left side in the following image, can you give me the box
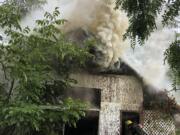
[0,3,89,135]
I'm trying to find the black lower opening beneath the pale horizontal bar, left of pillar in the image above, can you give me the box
[65,111,99,135]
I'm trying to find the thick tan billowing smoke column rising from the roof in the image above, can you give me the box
[61,0,128,69]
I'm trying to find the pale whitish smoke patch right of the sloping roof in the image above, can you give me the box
[122,28,174,89]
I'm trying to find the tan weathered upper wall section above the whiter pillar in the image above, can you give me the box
[72,73,143,111]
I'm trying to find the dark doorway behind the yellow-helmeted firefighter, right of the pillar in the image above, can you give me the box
[121,112,140,135]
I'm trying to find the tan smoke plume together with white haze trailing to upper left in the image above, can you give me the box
[22,0,128,70]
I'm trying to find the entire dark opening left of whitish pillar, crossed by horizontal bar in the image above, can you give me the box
[62,87,101,135]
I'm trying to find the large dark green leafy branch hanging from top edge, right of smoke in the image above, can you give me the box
[116,0,164,46]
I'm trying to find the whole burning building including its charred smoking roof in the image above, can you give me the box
[60,20,176,135]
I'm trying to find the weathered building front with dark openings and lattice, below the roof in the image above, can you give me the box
[58,72,175,135]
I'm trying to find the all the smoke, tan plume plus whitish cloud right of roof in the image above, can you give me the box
[1,0,180,102]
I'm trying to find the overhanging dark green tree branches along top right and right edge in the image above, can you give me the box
[115,0,180,90]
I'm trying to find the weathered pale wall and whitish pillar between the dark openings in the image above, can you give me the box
[72,73,143,135]
